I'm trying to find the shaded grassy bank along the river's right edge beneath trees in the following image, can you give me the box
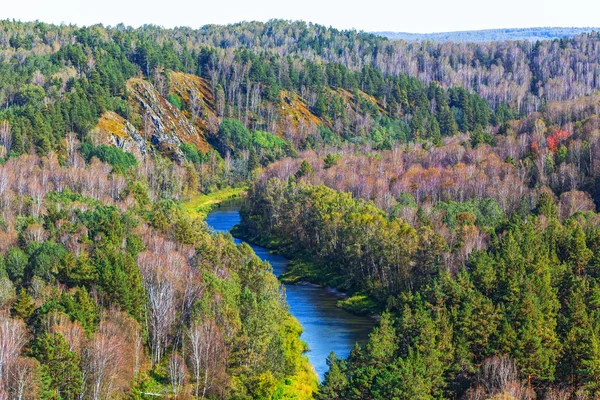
[231,224,384,319]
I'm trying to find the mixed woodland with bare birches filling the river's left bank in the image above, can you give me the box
[0,148,316,399]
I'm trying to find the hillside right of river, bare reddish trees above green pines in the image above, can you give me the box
[233,33,600,399]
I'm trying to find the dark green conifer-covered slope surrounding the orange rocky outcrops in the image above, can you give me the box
[0,17,496,161]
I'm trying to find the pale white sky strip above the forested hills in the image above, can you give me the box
[0,0,600,33]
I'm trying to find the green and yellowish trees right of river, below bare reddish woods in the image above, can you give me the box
[243,180,600,399]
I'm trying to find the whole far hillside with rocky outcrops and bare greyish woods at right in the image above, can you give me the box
[1,21,600,159]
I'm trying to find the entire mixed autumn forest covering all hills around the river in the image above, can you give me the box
[0,17,600,400]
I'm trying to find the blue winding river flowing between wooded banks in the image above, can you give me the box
[206,202,375,381]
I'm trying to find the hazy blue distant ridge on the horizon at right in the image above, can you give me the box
[373,28,600,42]
